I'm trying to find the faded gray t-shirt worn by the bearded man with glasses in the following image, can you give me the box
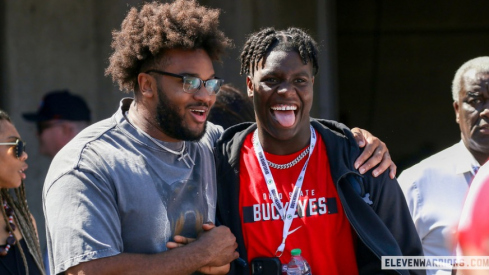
[43,98,222,274]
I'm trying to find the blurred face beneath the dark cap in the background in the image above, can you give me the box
[37,120,72,158]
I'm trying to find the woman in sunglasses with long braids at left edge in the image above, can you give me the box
[0,110,44,274]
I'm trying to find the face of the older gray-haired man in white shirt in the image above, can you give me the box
[453,69,489,162]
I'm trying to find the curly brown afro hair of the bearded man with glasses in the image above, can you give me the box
[105,0,232,92]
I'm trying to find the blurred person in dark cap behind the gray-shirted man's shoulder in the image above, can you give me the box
[22,90,90,158]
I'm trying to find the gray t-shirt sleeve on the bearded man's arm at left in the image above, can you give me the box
[44,170,123,274]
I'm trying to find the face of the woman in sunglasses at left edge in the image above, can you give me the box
[0,120,27,188]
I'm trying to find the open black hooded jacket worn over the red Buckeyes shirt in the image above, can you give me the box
[214,119,425,274]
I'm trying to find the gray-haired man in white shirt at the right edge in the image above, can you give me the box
[399,57,489,274]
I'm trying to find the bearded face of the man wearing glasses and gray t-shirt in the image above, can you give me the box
[154,49,216,140]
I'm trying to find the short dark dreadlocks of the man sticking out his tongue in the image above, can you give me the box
[240,28,319,75]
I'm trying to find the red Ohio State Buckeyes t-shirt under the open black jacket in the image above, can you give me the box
[239,134,358,274]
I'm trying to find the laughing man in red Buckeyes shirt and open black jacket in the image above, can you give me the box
[215,28,424,274]
